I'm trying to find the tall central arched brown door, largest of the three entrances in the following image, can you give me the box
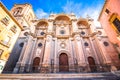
[59,53,69,72]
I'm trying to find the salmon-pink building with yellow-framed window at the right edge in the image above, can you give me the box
[98,0,120,53]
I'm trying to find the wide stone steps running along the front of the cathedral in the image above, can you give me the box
[0,72,120,80]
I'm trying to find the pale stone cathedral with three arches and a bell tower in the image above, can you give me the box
[4,4,120,73]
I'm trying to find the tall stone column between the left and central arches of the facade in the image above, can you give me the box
[42,19,53,72]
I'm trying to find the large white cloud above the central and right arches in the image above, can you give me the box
[62,1,102,20]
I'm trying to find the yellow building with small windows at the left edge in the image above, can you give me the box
[0,2,22,73]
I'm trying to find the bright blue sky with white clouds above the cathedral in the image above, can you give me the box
[1,0,104,20]
